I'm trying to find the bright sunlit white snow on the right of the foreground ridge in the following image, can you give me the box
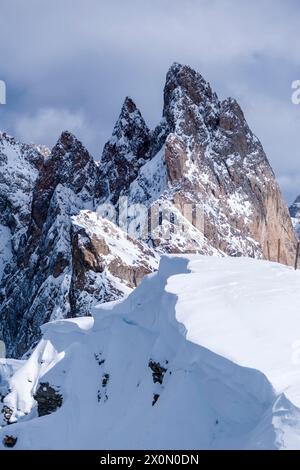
[168,257,300,407]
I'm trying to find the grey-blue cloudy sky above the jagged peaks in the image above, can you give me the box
[0,0,300,202]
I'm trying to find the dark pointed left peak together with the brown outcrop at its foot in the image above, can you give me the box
[0,132,156,357]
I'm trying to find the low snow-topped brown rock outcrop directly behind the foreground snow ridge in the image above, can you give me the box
[71,211,158,315]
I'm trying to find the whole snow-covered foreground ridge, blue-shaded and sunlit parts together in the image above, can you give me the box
[0,255,300,449]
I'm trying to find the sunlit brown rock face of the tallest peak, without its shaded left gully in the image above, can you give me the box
[164,64,295,264]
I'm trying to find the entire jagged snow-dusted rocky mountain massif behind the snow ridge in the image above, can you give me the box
[0,63,296,357]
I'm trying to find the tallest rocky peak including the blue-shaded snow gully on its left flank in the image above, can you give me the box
[104,64,296,264]
